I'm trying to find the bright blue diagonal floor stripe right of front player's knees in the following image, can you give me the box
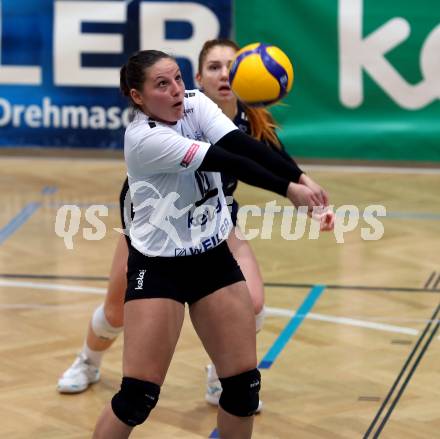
[258,285,325,369]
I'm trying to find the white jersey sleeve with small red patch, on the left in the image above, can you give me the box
[124,124,210,178]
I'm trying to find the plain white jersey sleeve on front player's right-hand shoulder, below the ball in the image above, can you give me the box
[196,91,237,144]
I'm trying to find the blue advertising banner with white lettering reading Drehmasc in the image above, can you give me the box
[0,0,232,148]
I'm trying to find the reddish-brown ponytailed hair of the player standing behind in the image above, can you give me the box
[198,38,281,148]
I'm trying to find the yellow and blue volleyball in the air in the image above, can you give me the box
[229,43,294,107]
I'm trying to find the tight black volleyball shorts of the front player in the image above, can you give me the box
[125,241,245,305]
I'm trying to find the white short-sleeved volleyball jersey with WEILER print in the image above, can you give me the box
[124,90,237,256]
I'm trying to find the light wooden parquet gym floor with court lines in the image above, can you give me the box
[0,157,440,439]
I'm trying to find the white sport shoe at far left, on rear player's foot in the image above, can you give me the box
[57,354,100,393]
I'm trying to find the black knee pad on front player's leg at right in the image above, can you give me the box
[219,369,261,417]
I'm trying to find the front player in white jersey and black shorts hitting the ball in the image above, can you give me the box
[94,50,330,438]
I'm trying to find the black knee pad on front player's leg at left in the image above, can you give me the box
[112,377,160,427]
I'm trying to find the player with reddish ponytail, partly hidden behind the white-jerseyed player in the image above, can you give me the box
[58,39,334,416]
